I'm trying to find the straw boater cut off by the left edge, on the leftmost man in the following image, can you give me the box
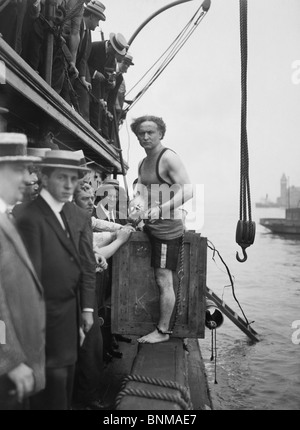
[0,133,41,164]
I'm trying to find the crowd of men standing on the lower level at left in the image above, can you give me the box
[0,138,134,410]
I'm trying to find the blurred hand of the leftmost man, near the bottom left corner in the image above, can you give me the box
[8,363,34,403]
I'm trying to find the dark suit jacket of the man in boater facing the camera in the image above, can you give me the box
[17,196,95,367]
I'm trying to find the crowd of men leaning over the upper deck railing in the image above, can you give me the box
[0,0,133,143]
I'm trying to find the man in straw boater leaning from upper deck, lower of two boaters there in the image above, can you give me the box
[88,33,128,139]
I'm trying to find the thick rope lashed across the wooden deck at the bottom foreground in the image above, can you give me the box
[116,375,193,410]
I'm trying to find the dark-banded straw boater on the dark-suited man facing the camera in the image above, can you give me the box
[40,149,90,173]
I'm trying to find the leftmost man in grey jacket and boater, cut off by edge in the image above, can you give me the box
[0,133,45,410]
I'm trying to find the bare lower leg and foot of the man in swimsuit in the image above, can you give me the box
[138,268,175,343]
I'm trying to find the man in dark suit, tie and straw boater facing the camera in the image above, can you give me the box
[17,150,96,410]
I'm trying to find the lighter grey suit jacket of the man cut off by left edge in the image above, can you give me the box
[0,214,45,392]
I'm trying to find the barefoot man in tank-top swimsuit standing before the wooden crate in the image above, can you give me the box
[131,116,193,343]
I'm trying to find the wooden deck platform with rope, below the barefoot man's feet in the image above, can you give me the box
[103,336,213,410]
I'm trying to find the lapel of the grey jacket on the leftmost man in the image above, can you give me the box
[0,214,43,294]
